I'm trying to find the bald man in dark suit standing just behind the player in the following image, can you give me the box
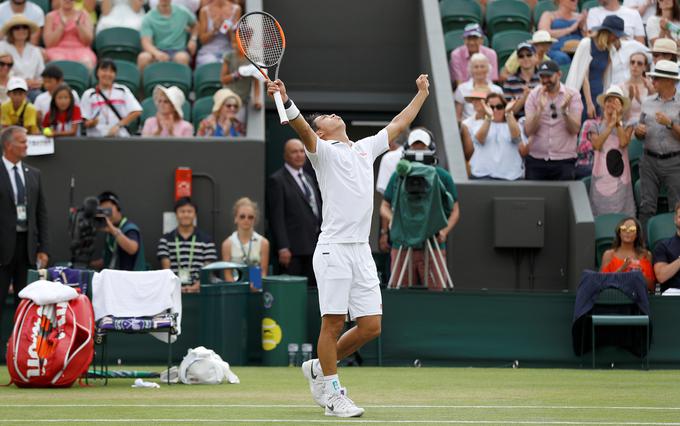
[267,139,321,286]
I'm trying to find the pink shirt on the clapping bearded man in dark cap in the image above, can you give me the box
[524,83,583,160]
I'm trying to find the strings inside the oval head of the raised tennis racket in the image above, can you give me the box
[237,14,283,67]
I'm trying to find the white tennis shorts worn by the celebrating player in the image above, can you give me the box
[313,243,382,319]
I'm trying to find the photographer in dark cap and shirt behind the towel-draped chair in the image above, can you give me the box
[91,191,146,271]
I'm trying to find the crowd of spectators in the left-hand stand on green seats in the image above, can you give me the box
[0,0,255,137]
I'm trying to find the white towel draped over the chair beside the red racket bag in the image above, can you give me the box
[92,269,182,342]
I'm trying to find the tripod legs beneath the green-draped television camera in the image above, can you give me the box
[387,236,453,290]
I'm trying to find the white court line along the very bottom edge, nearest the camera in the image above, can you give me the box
[0,418,680,426]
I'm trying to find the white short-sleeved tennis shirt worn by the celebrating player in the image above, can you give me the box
[305,129,389,244]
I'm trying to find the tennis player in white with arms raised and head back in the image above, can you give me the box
[267,74,430,417]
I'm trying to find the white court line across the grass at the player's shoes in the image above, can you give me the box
[0,404,680,411]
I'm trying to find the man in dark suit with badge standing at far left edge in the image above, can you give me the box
[0,126,48,317]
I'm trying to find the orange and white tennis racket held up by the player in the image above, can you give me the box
[236,12,288,124]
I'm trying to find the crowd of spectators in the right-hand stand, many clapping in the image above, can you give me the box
[450,0,680,290]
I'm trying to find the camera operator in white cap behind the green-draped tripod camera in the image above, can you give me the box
[380,127,460,291]
